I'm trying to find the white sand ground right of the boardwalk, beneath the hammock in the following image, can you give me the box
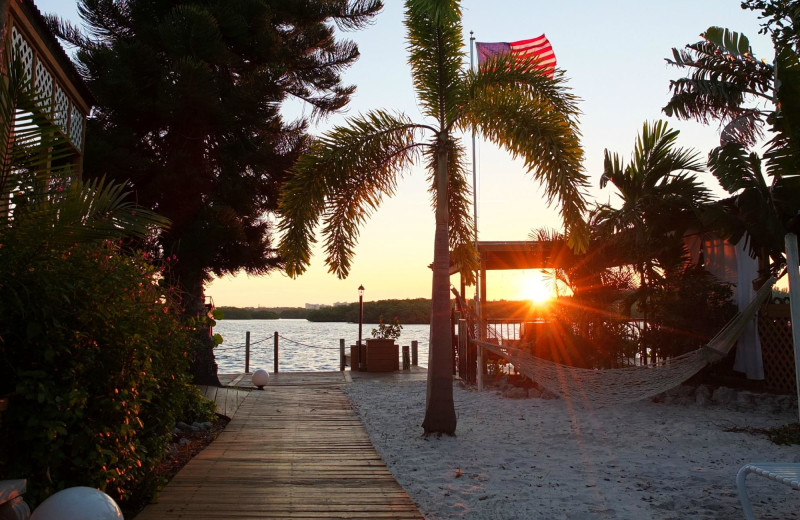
[344,380,800,520]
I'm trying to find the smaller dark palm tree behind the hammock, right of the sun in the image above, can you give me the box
[597,121,708,360]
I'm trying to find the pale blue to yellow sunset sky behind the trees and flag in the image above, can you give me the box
[35,0,772,307]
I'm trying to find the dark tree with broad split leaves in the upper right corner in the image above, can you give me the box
[664,21,800,286]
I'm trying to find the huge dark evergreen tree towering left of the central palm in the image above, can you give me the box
[51,0,382,384]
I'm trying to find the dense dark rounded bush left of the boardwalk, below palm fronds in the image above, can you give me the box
[0,244,212,504]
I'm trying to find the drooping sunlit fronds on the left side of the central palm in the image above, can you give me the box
[279,111,424,278]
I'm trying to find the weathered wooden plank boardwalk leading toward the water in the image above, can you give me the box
[136,374,424,520]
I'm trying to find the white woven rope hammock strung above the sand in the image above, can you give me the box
[476,278,775,408]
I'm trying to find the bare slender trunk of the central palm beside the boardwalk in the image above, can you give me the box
[422,137,456,435]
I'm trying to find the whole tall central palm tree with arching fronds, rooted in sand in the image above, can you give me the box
[280,0,587,435]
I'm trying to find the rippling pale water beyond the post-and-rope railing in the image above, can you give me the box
[209,319,429,374]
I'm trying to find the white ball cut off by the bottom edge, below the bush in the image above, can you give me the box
[31,486,123,520]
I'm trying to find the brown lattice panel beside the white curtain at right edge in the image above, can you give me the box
[758,304,797,394]
